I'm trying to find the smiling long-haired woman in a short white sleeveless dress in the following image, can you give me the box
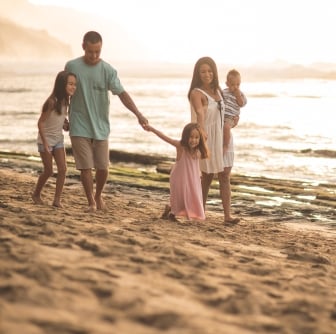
[188,57,240,224]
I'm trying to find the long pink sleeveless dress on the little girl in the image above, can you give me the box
[170,150,205,220]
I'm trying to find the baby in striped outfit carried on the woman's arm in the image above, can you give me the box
[222,70,247,153]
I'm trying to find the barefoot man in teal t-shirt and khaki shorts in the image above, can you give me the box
[65,31,148,212]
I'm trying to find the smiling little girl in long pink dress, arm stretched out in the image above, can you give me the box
[145,123,208,220]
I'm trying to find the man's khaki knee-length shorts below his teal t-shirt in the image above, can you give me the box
[70,136,110,170]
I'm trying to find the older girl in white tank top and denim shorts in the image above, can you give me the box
[32,71,76,207]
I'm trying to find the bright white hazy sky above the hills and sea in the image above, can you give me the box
[30,0,336,64]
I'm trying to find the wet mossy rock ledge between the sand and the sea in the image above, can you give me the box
[0,149,336,228]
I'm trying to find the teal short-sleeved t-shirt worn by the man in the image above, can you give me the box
[65,57,124,140]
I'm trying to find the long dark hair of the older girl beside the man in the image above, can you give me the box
[42,71,76,115]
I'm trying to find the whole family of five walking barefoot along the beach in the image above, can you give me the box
[32,31,247,224]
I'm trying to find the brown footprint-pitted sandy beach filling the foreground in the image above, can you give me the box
[0,152,336,334]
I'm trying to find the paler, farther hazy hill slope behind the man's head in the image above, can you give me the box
[0,0,146,62]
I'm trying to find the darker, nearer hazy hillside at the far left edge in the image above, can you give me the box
[0,18,72,60]
